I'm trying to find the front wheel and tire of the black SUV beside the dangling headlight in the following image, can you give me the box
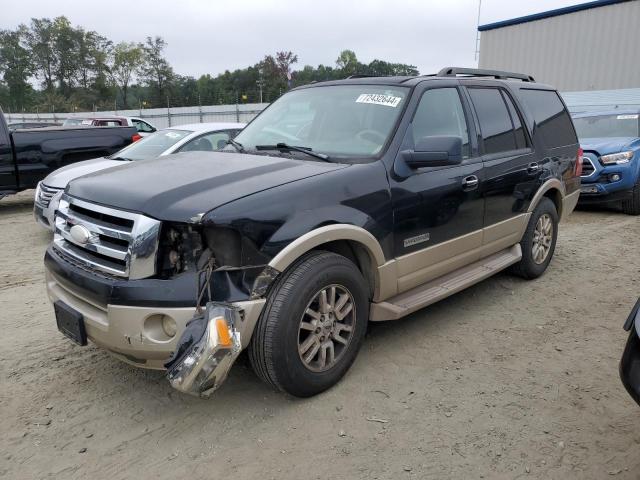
[248,251,369,397]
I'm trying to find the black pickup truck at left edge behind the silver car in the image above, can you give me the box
[0,110,140,198]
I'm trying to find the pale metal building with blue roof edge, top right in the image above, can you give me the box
[478,0,640,92]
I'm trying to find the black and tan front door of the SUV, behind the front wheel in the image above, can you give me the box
[390,85,484,292]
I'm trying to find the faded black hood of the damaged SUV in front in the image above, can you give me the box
[67,152,348,222]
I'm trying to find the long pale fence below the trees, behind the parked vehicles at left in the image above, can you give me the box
[5,103,269,129]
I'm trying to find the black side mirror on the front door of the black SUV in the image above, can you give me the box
[402,135,462,168]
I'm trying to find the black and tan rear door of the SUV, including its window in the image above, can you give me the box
[467,86,542,246]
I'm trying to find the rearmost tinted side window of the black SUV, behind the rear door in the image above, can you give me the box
[520,89,578,148]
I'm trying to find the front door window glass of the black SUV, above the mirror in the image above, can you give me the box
[412,88,470,158]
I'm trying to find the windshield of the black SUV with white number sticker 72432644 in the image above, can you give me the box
[235,85,408,158]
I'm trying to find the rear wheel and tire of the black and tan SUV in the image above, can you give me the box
[512,197,559,280]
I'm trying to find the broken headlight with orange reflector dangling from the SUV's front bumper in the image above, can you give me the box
[165,302,242,398]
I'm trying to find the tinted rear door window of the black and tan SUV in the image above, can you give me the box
[469,88,517,154]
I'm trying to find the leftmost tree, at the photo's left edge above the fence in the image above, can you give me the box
[0,30,32,108]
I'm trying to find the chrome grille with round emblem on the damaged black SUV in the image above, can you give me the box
[53,195,160,279]
